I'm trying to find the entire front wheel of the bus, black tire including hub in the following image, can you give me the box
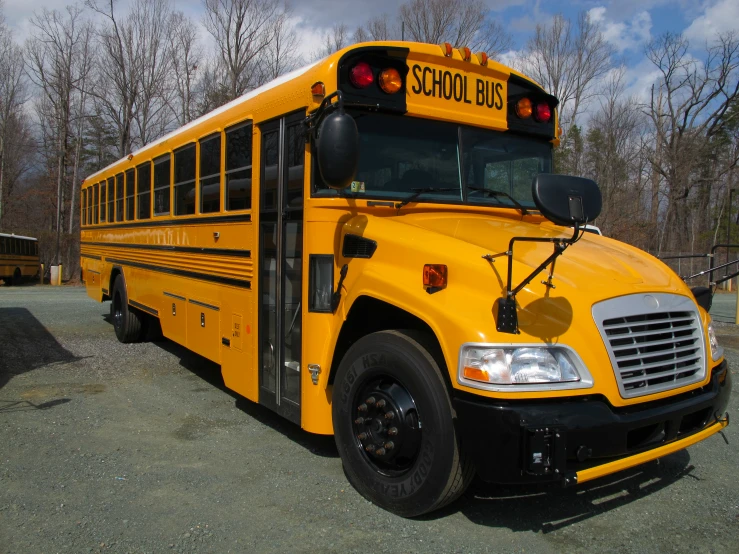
[332,331,472,517]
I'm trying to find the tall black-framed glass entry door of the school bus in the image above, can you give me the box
[259,113,305,424]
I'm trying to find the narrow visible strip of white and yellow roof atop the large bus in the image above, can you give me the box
[83,41,542,186]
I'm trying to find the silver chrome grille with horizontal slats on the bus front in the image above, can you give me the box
[593,294,705,398]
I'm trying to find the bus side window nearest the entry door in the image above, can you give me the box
[226,123,252,210]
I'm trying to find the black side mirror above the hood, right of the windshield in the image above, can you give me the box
[531,173,602,227]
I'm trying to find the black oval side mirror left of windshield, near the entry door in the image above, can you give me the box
[316,109,359,189]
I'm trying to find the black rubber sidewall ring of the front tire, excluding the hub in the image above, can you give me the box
[332,332,456,517]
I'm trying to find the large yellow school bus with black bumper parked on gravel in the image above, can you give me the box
[81,42,731,516]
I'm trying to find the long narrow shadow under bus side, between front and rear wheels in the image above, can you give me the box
[155,338,339,458]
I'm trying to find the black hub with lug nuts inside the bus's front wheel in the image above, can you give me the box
[353,378,421,474]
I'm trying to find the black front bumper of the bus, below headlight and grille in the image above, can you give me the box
[453,361,731,483]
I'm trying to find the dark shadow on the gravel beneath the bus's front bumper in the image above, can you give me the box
[442,450,700,534]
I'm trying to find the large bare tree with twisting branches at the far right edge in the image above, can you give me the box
[644,33,739,252]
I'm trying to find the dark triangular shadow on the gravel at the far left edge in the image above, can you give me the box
[0,308,80,389]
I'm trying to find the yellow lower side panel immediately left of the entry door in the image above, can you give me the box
[220,290,259,402]
